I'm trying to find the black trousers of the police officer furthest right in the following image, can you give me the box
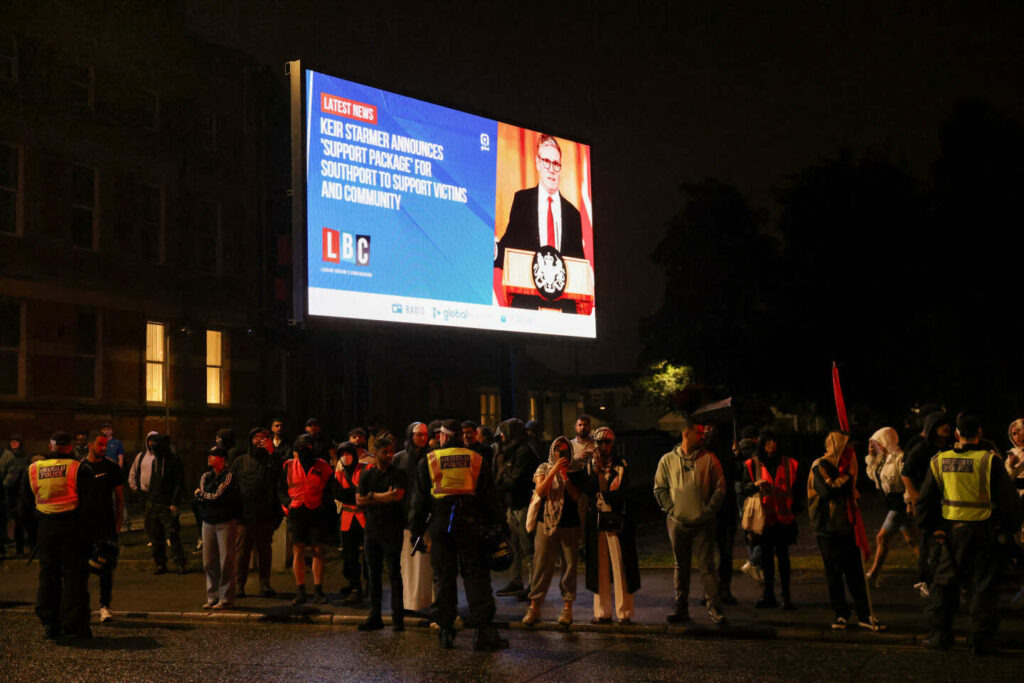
[926,522,1002,645]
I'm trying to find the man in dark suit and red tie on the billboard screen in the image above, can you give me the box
[495,135,584,268]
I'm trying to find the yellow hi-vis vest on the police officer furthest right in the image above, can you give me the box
[932,451,992,522]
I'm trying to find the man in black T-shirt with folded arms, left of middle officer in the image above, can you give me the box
[355,434,408,631]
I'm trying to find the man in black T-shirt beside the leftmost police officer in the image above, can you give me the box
[81,434,125,623]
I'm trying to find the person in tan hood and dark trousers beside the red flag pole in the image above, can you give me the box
[807,432,885,631]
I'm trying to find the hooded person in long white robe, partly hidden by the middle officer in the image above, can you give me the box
[394,422,434,611]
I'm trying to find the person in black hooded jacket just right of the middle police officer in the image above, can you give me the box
[493,418,540,596]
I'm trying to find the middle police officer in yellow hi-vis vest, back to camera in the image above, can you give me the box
[410,420,509,650]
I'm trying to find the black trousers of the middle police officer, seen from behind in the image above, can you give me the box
[430,514,495,629]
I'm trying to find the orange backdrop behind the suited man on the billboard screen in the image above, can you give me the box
[495,122,594,267]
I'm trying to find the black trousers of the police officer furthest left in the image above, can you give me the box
[36,517,90,633]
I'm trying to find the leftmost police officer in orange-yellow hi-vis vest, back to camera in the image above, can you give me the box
[26,432,92,640]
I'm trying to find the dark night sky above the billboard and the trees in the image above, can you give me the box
[188,0,1024,373]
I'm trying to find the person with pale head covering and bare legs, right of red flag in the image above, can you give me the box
[865,427,918,584]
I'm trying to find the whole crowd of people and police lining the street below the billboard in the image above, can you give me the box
[0,411,1024,652]
